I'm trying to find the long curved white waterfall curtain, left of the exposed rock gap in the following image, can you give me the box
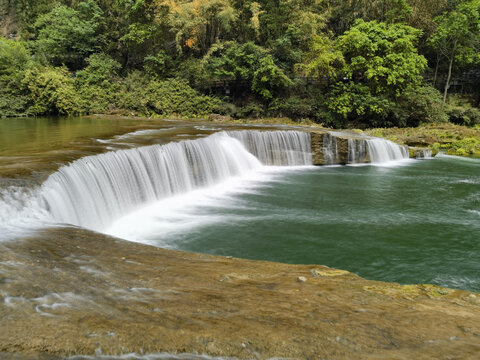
[40,131,312,230]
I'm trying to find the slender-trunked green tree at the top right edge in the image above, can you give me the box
[428,0,480,103]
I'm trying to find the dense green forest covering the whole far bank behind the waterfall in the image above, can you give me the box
[0,0,480,127]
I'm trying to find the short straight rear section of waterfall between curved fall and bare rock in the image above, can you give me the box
[227,131,312,166]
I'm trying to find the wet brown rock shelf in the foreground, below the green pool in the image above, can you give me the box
[0,228,480,359]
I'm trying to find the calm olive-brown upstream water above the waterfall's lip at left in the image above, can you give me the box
[0,116,213,180]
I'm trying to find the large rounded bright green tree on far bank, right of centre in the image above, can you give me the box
[314,20,427,125]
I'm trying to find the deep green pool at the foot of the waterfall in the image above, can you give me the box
[153,157,480,292]
